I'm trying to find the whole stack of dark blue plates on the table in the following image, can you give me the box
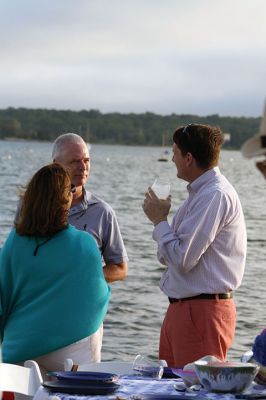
[42,371,119,395]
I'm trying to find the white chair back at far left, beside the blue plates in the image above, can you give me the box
[0,360,42,396]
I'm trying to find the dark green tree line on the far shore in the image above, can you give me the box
[0,107,261,149]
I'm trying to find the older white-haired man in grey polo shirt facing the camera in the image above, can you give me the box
[52,133,128,283]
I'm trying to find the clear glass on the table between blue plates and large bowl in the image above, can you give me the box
[133,354,167,379]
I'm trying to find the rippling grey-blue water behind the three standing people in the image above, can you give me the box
[0,141,266,361]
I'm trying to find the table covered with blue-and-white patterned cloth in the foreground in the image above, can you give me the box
[33,376,266,400]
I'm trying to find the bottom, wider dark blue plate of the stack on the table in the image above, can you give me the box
[42,380,119,395]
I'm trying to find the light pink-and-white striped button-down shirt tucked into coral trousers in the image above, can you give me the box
[153,167,247,298]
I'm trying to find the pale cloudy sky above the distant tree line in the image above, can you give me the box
[0,0,266,117]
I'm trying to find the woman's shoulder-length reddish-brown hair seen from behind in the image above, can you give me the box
[15,163,71,237]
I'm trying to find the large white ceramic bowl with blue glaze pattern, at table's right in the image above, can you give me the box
[195,360,259,393]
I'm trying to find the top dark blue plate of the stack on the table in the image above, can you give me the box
[47,371,118,384]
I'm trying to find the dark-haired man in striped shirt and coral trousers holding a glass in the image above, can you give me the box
[143,124,247,368]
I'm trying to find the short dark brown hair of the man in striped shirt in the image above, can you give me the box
[173,124,223,169]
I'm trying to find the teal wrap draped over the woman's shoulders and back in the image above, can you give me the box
[0,225,110,363]
